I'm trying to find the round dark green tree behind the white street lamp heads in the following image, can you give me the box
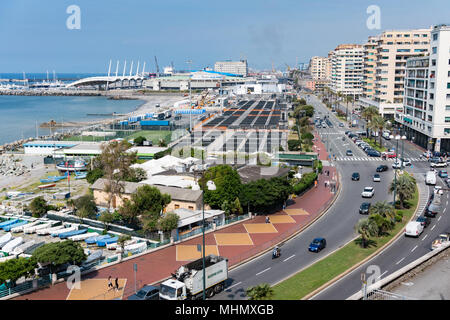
[199,164,242,209]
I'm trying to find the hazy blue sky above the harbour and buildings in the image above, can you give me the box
[0,0,450,74]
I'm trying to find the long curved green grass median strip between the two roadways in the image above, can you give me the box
[273,190,419,300]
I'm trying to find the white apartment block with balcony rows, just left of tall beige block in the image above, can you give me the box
[330,44,364,98]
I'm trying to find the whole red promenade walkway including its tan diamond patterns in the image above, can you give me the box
[16,131,336,300]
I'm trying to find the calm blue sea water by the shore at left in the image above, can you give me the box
[0,96,143,144]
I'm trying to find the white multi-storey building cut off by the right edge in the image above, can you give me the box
[395,25,450,152]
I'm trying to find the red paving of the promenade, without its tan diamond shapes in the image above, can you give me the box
[15,131,336,300]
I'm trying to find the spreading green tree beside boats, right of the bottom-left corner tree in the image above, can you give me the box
[31,240,87,273]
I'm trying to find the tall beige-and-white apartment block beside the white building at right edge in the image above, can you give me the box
[360,29,430,118]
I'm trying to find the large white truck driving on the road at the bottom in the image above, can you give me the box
[159,254,228,300]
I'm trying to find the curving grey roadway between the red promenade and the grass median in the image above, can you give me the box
[213,92,393,300]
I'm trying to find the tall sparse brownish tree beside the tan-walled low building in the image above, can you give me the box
[99,140,137,209]
